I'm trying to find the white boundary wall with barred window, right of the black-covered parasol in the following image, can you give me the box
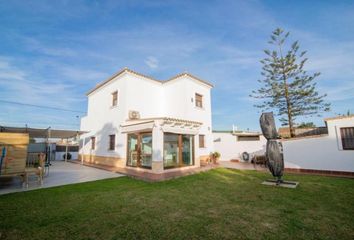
[283,117,354,172]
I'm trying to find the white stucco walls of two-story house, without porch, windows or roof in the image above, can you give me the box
[80,70,213,163]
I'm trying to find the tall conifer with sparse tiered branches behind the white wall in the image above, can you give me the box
[250,28,330,137]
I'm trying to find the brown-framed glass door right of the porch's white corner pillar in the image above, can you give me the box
[164,133,194,168]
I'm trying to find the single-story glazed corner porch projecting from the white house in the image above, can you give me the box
[121,118,202,174]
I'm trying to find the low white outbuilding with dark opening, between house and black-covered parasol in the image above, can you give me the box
[213,130,267,162]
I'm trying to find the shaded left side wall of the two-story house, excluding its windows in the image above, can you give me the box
[80,74,129,160]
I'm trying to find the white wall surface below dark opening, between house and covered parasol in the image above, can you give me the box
[213,132,267,161]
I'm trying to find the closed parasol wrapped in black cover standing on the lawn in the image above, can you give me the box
[259,112,284,185]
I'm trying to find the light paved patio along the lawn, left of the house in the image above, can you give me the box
[0,161,124,195]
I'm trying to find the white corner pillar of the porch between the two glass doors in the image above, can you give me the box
[151,123,163,173]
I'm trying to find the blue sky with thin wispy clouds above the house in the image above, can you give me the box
[0,0,354,130]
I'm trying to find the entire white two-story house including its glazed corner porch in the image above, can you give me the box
[80,68,213,174]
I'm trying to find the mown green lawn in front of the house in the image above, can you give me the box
[0,168,354,239]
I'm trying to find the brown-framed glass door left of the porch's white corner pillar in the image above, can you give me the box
[127,133,152,168]
